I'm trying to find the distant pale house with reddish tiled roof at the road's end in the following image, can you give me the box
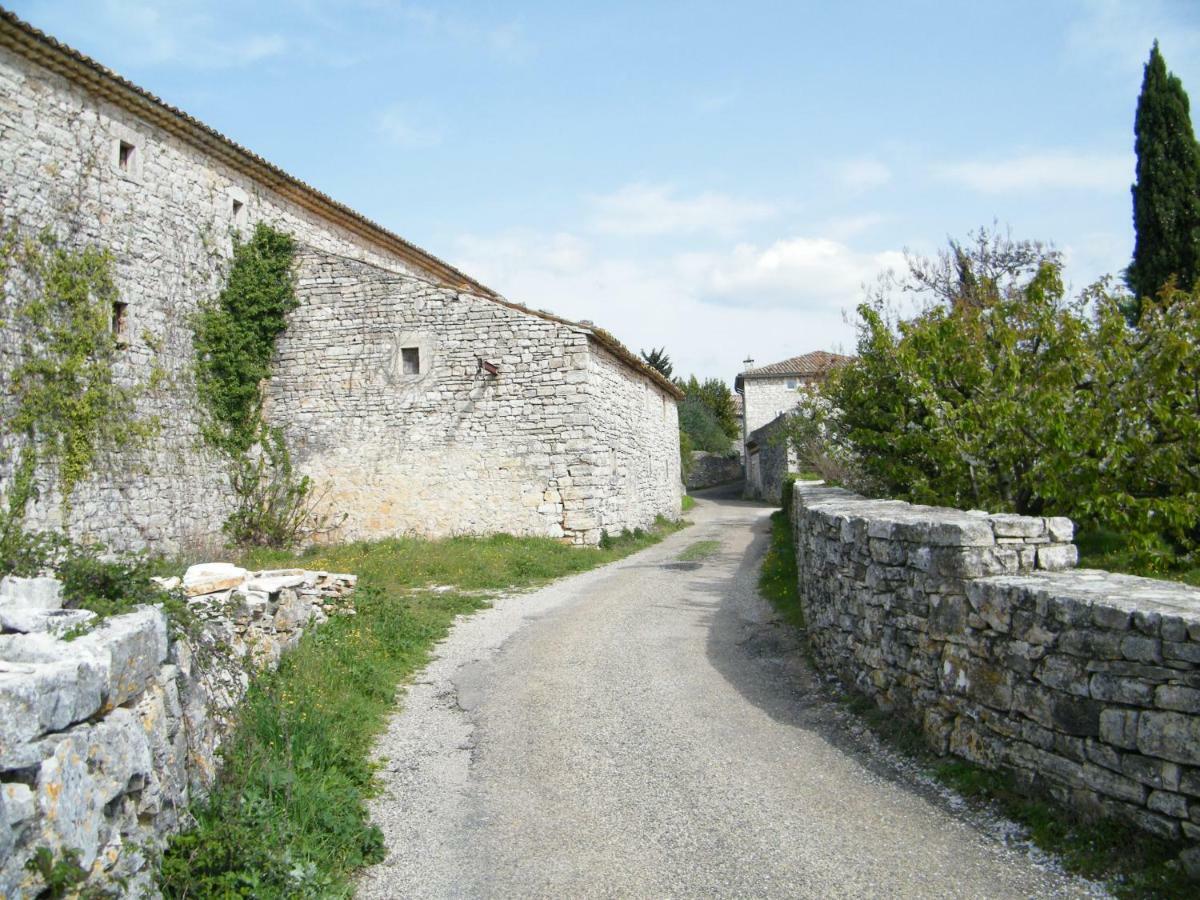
[733,350,850,502]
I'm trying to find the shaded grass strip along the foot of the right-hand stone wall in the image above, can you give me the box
[758,510,1198,900]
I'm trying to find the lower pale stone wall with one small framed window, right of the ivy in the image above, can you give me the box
[276,248,679,544]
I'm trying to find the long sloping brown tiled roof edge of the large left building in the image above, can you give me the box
[0,7,683,400]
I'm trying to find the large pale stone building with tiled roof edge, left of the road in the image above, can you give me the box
[0,11,680,552]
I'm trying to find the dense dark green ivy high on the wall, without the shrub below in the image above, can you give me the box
[194,223,298,457]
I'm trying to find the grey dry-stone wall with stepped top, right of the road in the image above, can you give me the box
[792,484,1200,844]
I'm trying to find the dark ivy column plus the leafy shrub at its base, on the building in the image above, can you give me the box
[193,223,336,546]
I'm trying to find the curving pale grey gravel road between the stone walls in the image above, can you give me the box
[359,491,1103,898]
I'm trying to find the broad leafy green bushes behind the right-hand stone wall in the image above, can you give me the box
[793,234,1200,569]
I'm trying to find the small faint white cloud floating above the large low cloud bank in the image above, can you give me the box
[590,184,778,236]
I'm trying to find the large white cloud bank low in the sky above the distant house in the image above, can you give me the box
[454,230,901,382]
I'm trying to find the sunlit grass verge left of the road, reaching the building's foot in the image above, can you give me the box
[160,522,683,898]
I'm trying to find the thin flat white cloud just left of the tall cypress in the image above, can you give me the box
[935,151,1134,193]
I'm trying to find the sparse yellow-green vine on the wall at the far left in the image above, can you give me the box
[0,229,158,541]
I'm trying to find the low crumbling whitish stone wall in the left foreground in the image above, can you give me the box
[0,564,355,898]
